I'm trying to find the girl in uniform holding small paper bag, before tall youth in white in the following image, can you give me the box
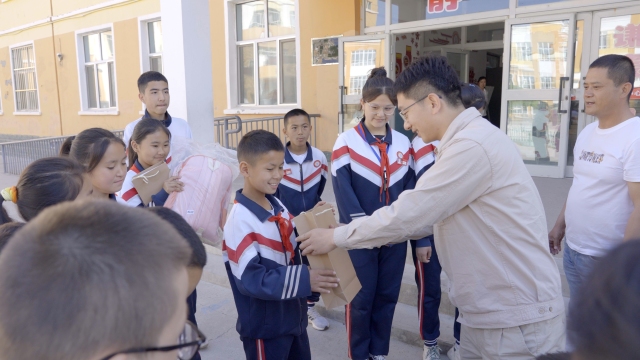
[118,119,184,207]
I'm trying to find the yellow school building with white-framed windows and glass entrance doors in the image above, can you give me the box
[0,0,640,178]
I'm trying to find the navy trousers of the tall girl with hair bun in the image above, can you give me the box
[345,243,407,360]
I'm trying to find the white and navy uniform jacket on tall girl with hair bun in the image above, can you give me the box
[331,120,415,228]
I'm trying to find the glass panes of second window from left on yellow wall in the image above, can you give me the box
[78,29,117,110]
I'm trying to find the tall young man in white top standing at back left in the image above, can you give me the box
[124,71,193,165]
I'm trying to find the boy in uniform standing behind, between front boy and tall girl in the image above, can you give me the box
[275,109,329,331]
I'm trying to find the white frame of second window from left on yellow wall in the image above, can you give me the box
[75,23,120,115]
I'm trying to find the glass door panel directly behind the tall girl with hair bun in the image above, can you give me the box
[338,34,394,132]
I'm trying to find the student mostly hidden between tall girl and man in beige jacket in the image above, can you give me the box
[410,136,444,360]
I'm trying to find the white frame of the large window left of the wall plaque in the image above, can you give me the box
[224,0,302,114]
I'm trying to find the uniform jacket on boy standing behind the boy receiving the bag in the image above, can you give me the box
[275,143,328,216]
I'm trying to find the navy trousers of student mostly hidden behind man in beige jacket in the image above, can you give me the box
[411,240,442,342]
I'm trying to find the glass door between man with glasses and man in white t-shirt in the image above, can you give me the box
[500,14,576,178]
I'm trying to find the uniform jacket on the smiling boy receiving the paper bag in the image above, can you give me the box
[222,190,311,339]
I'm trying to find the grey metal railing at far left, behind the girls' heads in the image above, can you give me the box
[0,130,124,175]
